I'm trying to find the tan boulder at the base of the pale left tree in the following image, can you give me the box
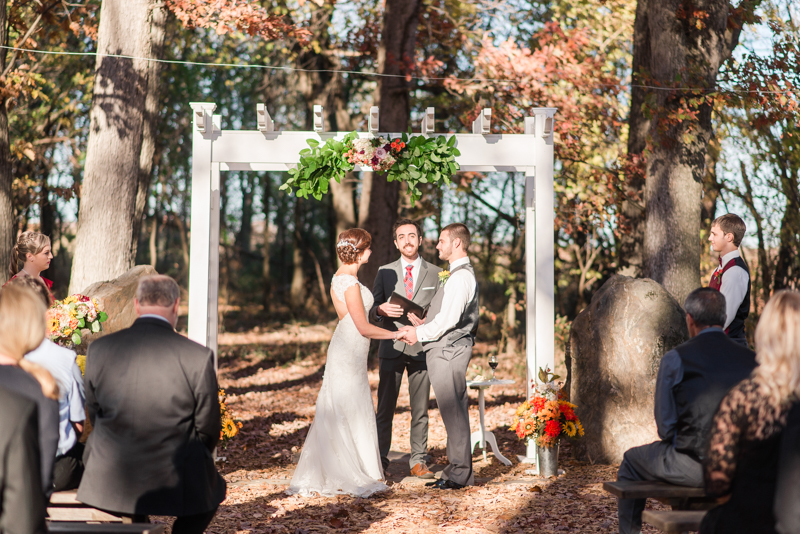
[81,265,158,350]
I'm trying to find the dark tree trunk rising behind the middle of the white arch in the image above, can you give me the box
[359,0,422,287]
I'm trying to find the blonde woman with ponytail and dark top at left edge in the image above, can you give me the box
[0,286,58,496]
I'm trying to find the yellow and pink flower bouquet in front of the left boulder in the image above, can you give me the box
[47,294,108,348]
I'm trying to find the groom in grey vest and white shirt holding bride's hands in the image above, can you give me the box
[403,223,480,489]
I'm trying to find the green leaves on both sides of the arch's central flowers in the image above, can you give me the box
[280,132,461,205]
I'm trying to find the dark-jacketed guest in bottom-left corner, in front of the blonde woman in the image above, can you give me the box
[0,387,47,534]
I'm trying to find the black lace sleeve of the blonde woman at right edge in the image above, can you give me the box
[703,375,791,496]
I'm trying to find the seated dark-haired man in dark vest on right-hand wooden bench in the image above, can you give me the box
[617,288,756,534]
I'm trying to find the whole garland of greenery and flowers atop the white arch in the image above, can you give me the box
[281,132,461,205]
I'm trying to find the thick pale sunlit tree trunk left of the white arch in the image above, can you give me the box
[70,0,166,293]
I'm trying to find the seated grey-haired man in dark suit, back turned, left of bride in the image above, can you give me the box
[78,275,225,534]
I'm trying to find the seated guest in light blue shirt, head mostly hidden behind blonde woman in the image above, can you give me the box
[7,276,86,491]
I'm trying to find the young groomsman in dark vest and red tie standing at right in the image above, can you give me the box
[708,213,750,347]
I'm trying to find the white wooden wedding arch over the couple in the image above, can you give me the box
[189,102,556,400]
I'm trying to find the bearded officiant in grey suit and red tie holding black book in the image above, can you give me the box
[369,219,441,478]
